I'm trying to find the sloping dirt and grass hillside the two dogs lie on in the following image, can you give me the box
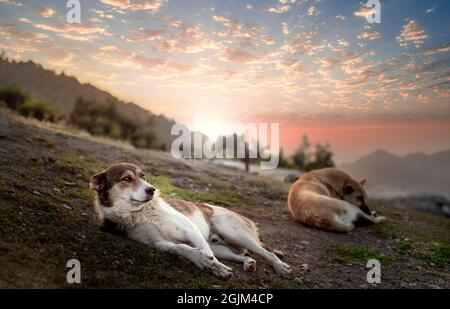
[0,110,450,288]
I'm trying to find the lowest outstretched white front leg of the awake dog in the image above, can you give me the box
[155,240,232,278]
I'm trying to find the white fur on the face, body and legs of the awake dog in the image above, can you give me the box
[95,180,291,277]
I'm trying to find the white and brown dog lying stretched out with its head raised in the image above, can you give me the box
[90,163,291,278]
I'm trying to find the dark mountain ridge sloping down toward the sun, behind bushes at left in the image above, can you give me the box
[0,58,175,148]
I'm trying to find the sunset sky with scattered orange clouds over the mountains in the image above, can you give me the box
[0,0,450,162]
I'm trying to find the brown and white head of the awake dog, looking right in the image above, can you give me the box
[89,163,158,211]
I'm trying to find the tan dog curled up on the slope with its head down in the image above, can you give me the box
[288,168,385,232]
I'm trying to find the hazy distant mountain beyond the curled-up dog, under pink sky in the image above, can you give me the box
[341,150,450,198]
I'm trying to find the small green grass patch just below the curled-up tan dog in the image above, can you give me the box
[328,245,392,266]
